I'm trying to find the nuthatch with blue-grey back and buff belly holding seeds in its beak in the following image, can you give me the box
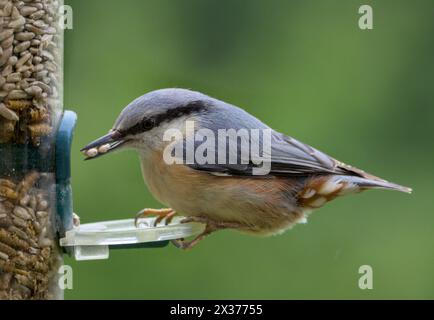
[81,88,412,249]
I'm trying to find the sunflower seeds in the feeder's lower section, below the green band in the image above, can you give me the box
[0,172,59,300]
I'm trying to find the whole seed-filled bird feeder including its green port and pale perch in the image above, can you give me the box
[0,0,203,300]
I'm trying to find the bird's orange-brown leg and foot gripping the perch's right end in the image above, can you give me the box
[172,217,242,250]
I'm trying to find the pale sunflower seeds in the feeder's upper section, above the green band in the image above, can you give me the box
[0,0,63,146]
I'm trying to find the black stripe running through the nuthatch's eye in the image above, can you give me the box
[122,101,207,136]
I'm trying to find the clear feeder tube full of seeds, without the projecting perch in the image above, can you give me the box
[0,0,63,300]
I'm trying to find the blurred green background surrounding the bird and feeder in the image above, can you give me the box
[65,0,434,299]
